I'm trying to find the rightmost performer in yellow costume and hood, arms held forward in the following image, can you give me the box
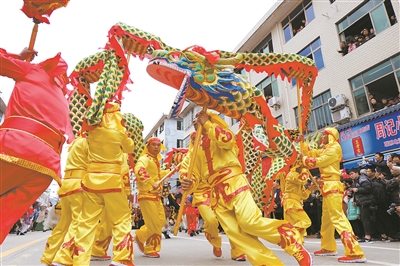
[302,128,366,262]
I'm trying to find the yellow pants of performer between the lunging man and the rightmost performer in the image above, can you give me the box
[283,198,311,244]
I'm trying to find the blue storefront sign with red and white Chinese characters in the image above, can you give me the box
[338,108,400,169]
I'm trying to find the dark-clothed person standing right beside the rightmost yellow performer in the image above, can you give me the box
[348,168,375,243]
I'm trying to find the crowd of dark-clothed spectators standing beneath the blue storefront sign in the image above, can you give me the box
[343,152,400,243]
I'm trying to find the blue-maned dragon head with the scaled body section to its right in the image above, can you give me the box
[147,46,318,212]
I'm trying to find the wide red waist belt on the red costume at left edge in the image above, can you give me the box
[0,116,65,154]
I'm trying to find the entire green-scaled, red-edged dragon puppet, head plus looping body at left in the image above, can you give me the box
[72,23,318,209]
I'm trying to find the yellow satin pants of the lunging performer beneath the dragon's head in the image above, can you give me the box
[215,189,301,265]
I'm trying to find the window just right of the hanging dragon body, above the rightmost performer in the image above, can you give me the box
[294,90,333,134]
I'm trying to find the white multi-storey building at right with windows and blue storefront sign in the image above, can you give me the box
[235,0,400,167]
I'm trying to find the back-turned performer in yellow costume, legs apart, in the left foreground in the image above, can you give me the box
[54,103,134,265]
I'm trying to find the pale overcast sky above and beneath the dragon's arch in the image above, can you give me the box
[0,0,276,135]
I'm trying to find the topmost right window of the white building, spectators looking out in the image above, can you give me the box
[337,0,397,54]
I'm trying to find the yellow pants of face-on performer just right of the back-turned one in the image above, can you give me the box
[136,199,166,254]
